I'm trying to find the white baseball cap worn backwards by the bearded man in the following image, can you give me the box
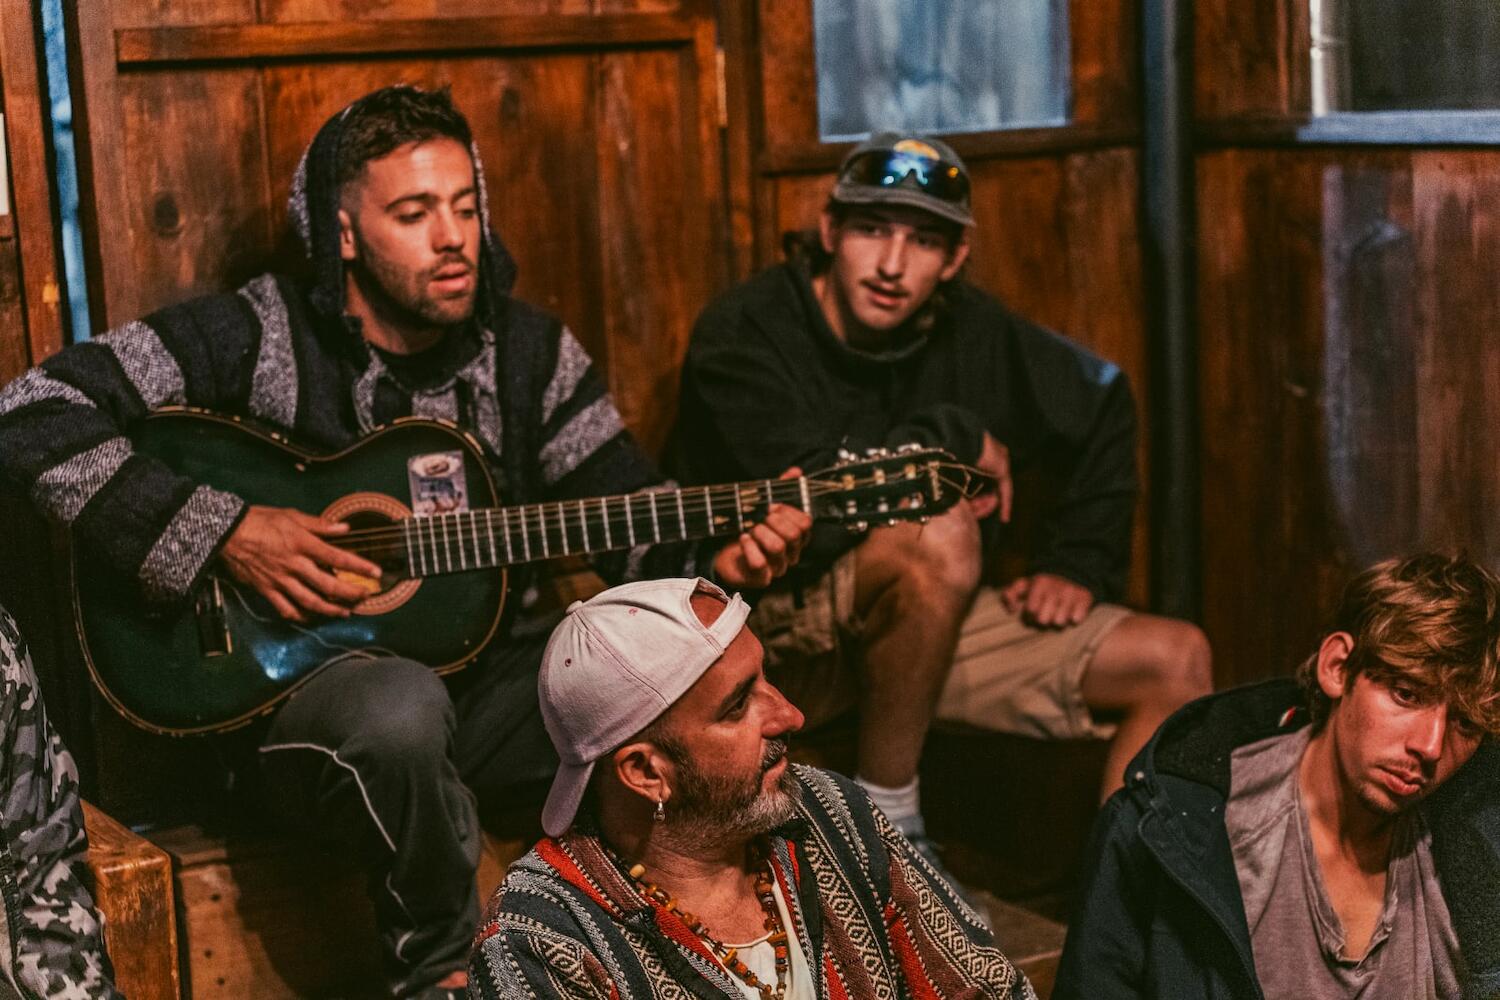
[537,577,750,837]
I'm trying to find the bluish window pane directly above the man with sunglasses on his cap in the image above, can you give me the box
[813,0,1068,141]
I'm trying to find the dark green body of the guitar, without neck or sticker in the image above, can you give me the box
[74,409,506,735]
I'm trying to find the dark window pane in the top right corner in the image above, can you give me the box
[1310,0,1500,111]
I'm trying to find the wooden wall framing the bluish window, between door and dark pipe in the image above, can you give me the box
[722,0,1151,604]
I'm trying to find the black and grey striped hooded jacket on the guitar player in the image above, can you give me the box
[0,88,698,611]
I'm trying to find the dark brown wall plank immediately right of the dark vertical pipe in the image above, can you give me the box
[1199,151,1347,687]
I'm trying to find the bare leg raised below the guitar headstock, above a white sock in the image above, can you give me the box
[855,504,980,789]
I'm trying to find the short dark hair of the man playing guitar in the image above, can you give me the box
[333,84,474,190]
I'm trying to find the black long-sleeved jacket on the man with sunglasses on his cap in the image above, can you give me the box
[678,262,1136,600]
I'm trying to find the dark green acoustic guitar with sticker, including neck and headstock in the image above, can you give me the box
[72,408,987,735]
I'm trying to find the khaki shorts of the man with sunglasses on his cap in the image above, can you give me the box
[750,552,1134,739]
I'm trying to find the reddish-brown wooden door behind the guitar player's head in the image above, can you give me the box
[69,0,728,448]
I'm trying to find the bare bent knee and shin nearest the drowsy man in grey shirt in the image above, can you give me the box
[1083,615,1214,801]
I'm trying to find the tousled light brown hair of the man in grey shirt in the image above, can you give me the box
[1298,552,1500,735]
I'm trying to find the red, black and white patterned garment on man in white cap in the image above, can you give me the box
[470,766,1037,1000]
